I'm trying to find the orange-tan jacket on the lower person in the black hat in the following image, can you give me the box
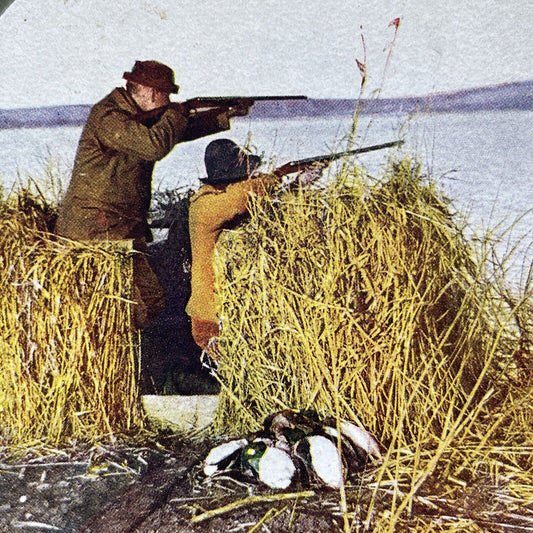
[186,174,279,322]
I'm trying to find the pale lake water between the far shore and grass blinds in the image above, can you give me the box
[0,111,533,286]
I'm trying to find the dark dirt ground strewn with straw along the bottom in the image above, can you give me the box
[4,436,533,533]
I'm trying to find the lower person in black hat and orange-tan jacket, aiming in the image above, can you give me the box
[186,139,323,361]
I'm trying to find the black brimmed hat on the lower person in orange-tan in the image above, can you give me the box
[201,139,261,185]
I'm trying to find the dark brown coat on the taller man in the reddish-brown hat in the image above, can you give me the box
[56,88,229,242]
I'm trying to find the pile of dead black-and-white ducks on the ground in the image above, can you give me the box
[203,410,382,489]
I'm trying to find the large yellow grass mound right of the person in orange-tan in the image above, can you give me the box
[214,160,533,531]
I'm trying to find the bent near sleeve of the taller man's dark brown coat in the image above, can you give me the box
[96,107,187,161]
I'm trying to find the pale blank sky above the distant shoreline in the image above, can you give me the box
[0,0,533,109]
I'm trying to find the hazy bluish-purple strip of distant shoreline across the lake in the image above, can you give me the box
[0,80,533,130]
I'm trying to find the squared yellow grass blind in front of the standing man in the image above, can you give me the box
[0,194,141,447]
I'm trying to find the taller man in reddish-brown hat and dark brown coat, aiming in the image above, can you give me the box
[55,61,244,327]
